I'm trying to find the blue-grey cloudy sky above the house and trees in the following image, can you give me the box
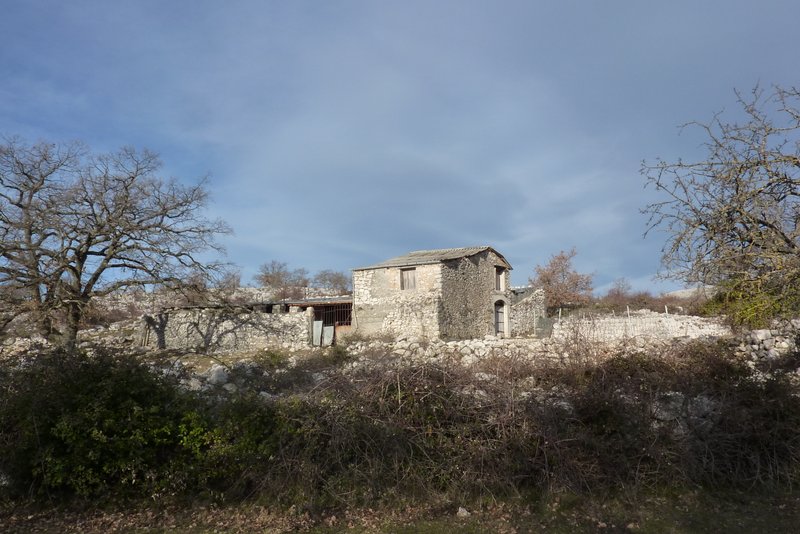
[0,0,800,293]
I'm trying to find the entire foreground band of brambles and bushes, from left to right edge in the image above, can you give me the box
[0,344,800,510]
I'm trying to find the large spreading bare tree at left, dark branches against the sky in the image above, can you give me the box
[0,138,229,346]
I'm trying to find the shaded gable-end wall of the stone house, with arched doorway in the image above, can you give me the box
[440,251,511,339]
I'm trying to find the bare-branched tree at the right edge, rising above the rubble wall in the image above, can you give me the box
[642,87,800,320]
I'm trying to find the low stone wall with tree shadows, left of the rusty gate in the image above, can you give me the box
[142,308,314,352]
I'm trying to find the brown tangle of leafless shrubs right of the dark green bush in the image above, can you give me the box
[0,343,800,511]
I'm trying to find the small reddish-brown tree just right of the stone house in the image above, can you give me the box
[530,247,592,312]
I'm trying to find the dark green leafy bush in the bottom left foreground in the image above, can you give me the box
[0,351,200,497]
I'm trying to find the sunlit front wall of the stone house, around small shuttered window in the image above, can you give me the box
[353,264,442,339]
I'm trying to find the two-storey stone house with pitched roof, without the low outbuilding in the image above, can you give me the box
[353,246,511,340]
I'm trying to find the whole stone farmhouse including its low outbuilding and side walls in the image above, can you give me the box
[142,246,544,351]
